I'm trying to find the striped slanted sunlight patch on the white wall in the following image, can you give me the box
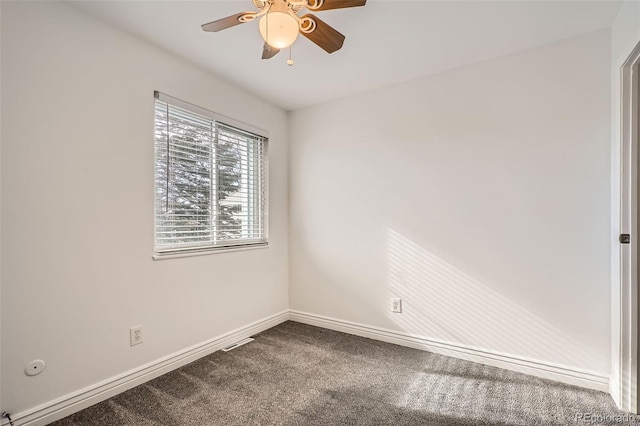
[387,229,607,369]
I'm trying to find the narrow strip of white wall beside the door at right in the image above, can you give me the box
[611,1,640,407]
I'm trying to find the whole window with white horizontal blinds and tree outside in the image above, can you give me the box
[155,92,268,258]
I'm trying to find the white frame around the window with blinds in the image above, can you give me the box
[153,91,269,260]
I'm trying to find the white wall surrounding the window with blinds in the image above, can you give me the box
[1,2,288,413]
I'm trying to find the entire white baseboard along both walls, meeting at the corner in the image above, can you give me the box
[8,311,610,426]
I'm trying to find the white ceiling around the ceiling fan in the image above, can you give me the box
[73,0,620,110]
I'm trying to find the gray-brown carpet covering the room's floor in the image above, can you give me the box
[54,322,629,426]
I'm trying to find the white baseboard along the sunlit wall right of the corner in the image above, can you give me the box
[289,311,609,393]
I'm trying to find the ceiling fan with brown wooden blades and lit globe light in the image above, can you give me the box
[202,0,367,61]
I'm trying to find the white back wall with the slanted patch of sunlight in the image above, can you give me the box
[289,31,611,377]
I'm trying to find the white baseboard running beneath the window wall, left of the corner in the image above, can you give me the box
[2,311,289,426]
